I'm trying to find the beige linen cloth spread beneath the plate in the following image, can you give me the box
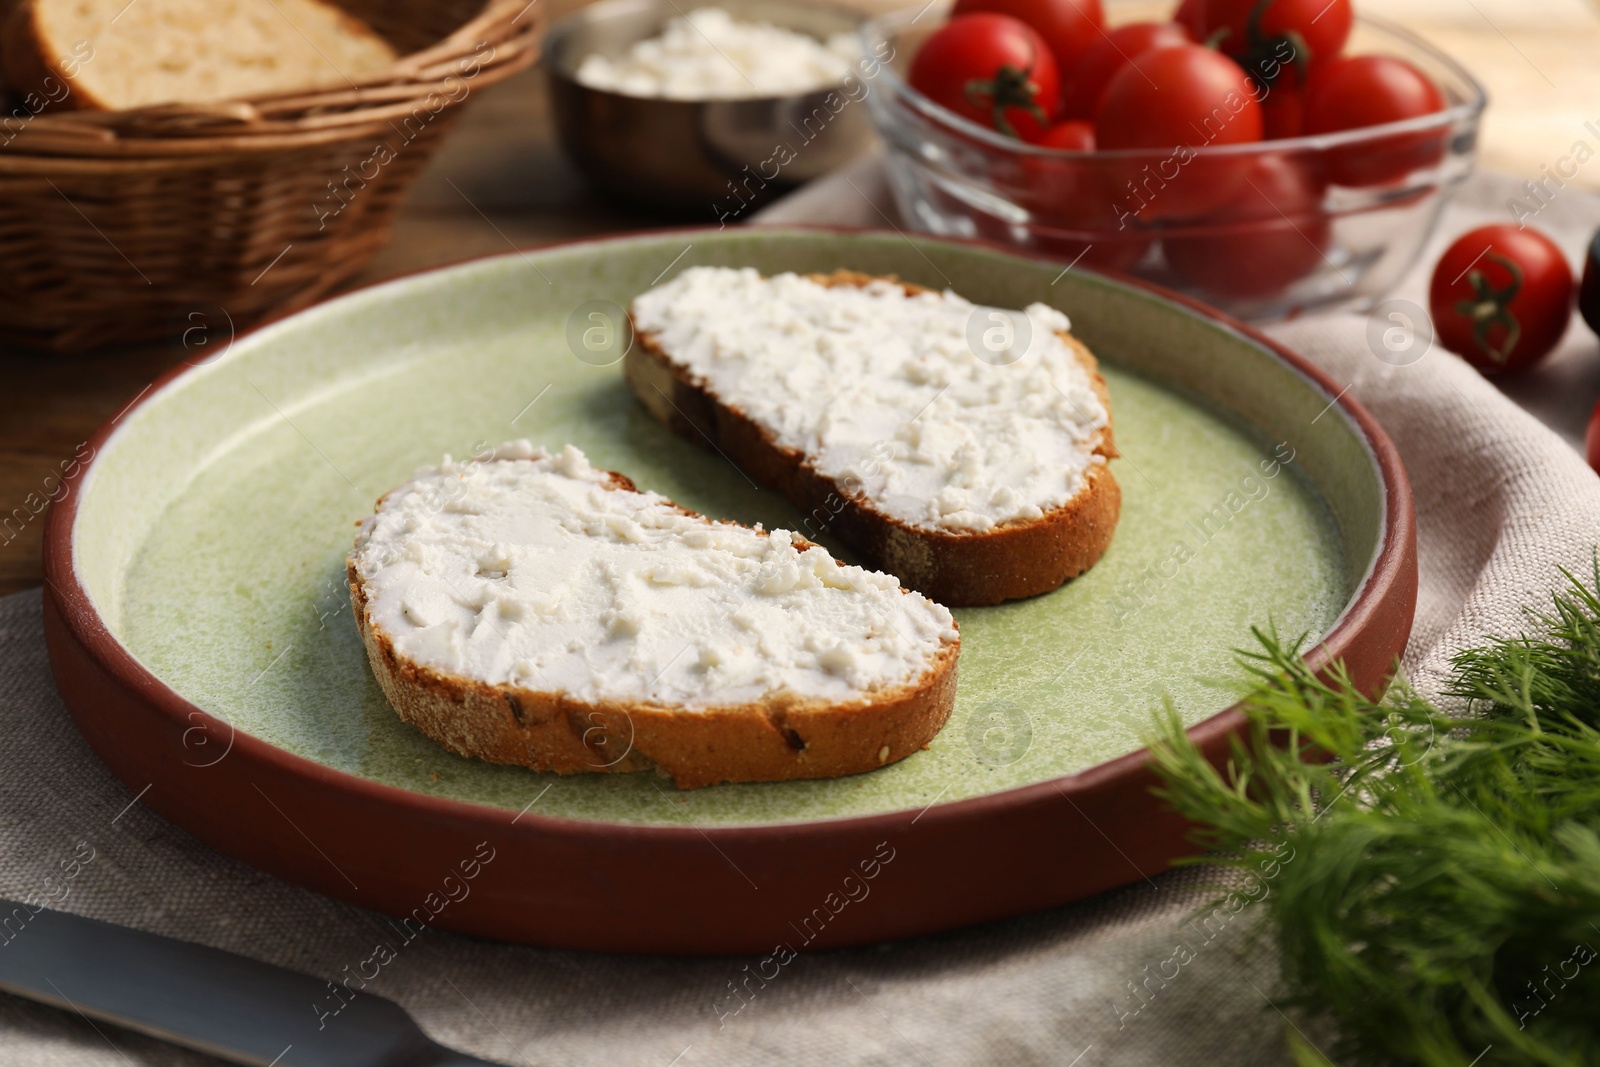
[0,162,1600,1067]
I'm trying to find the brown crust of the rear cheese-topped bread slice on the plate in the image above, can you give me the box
[622,270,1122,606]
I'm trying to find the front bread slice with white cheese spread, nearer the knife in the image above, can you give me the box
[347,442,960,789]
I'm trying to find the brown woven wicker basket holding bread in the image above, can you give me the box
[0,0,542,352]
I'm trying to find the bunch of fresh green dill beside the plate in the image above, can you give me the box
[1152,561,1600,1067]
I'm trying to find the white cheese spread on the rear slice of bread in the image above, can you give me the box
[630,267,1110,533]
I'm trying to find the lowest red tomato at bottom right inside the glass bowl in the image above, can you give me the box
[1162,155,1331,298]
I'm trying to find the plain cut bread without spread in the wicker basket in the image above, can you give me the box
[0,0,397,110]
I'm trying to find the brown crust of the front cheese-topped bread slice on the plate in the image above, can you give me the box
[346,474,960,789]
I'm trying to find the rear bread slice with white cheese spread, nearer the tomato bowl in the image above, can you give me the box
[624,267,1122,606]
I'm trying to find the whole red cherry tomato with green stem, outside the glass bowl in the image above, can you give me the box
[1427,222,1573,374]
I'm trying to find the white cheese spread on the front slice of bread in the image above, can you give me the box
[350,442,958,709]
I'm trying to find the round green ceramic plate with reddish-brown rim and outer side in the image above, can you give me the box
[46,230,1416,952]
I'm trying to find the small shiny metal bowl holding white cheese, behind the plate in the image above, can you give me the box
[544,0,878,222]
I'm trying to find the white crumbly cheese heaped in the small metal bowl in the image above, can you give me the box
[576,8,859,101]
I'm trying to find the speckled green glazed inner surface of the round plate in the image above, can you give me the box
[72,229,1384,827]
